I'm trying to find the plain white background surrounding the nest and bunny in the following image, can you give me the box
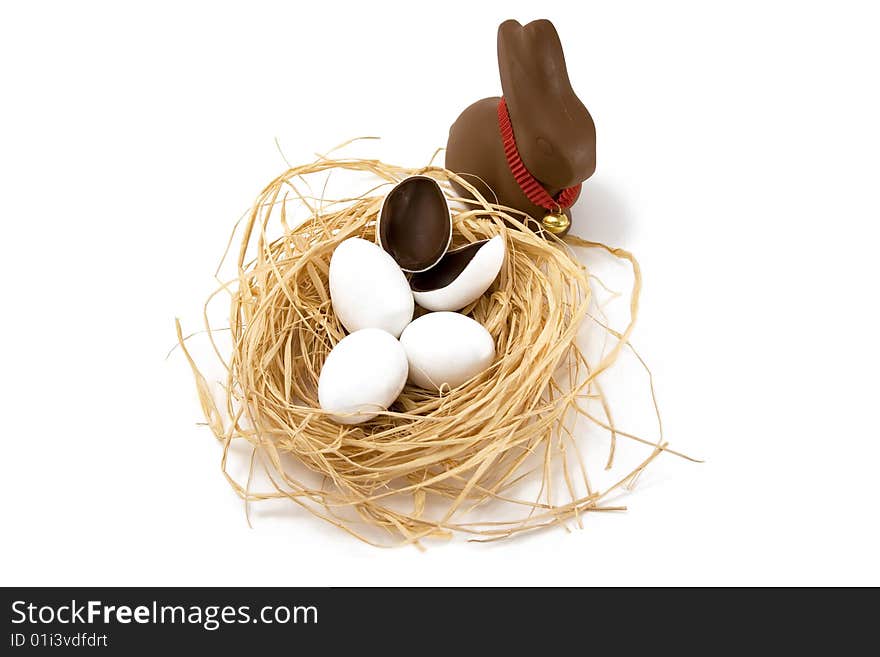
[0,0,880,585]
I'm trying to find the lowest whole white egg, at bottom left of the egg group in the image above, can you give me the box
[318,328,408,424]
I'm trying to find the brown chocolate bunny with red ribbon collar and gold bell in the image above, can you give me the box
[446,20,596,236]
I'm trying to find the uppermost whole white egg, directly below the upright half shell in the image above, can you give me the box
[330,237,415,337]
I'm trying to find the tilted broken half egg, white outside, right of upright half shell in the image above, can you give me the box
[409,235,506,311]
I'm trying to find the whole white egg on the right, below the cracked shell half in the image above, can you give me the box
[400,312,495,390]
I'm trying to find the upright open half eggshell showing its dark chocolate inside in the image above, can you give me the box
[376,176,452,272]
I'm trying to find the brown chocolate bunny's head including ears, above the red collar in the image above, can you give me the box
[498,20,596,188]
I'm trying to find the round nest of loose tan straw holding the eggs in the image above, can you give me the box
[177,146,680,546]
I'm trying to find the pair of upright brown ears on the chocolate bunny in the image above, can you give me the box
[498,19,573,98]
